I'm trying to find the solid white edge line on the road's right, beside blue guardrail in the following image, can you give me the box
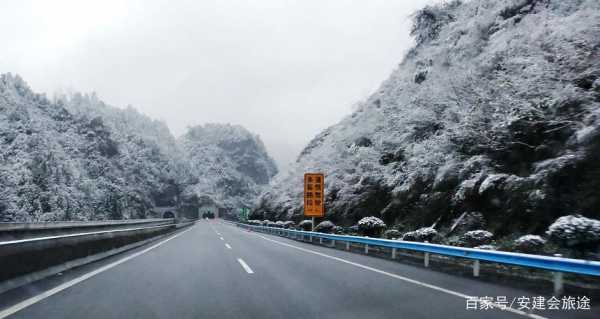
[254,233,548,319]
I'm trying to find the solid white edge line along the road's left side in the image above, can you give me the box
[0,226,194,319]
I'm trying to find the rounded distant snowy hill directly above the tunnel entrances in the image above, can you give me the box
[179,124,277,214]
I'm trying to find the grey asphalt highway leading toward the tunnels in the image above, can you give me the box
[0,220,599,319]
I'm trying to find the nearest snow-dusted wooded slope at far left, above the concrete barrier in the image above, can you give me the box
[0,74,173,221]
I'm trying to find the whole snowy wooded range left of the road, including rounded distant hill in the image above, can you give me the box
[0,74,276,221]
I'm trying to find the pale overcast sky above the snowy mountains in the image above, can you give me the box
[0,0,435,167]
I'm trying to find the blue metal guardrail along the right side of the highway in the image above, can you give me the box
[237,223,600,278]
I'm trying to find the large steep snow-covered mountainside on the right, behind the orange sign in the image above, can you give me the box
[253,0,600,240]
